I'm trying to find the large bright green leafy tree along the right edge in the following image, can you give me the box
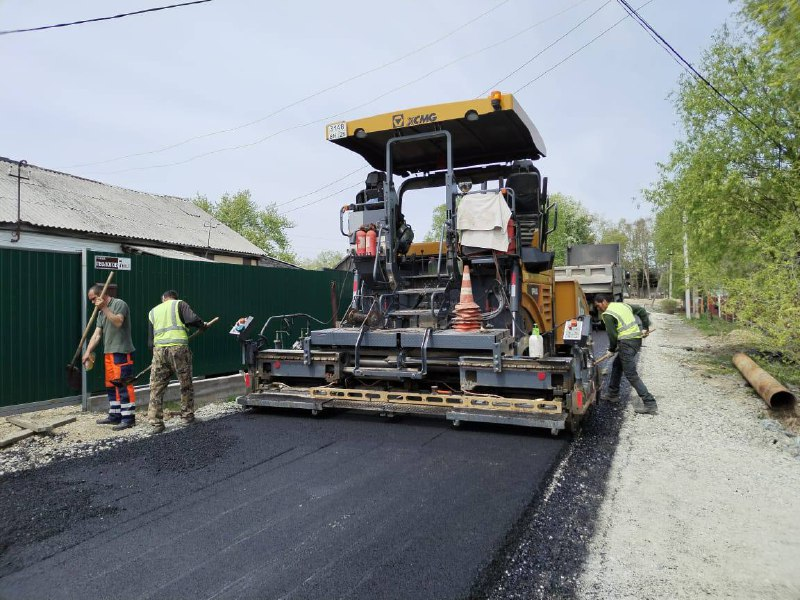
[647,0,800,361]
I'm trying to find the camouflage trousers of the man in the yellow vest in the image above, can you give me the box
[147,345,194,425]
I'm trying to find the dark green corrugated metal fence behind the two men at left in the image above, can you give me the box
[0,249,352,406]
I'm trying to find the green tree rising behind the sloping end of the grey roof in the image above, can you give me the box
[194,190,297,262]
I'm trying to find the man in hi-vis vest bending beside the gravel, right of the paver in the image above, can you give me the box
[594,294,658,415]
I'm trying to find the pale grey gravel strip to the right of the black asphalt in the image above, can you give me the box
[576,313,800,600]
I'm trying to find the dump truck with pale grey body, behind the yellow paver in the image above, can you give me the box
[555,244,627,328]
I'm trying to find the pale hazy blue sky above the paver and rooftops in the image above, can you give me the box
[0,0,736,258]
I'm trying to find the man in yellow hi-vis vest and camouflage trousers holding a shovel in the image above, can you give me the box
[147,290,208,433]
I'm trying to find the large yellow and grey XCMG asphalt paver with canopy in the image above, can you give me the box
[236,92,598,435]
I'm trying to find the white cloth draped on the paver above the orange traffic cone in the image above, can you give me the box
[456,193,511,252]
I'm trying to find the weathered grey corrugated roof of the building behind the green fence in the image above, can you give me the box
[0,157,266,256]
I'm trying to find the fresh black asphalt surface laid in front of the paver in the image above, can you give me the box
[0,332,619,600]
